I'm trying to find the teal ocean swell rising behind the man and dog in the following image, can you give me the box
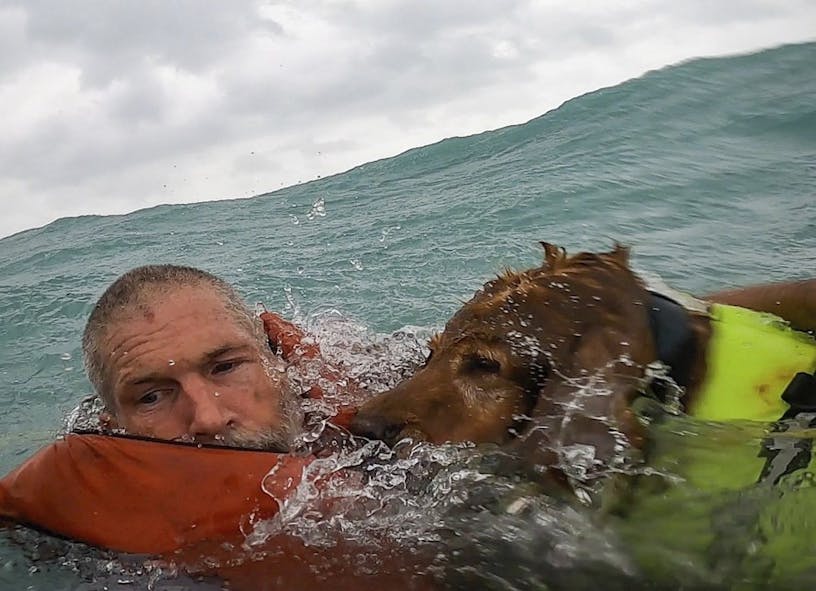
[0,43,816,589]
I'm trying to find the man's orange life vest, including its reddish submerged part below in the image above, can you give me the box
[0,434,435,591]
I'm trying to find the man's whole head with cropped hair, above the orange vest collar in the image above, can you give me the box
[82,265,297,447]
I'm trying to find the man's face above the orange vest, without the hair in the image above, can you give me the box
[101,285,294,444]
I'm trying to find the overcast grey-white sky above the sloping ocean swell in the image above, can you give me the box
[0,0,816,236]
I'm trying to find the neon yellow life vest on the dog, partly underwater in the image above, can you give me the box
[613,304,816,589]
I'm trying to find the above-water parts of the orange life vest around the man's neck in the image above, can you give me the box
[0,312,352,554]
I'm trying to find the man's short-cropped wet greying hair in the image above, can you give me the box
[82,265,263,410]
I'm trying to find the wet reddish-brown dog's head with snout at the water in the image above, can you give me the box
[352,243,654,456]
